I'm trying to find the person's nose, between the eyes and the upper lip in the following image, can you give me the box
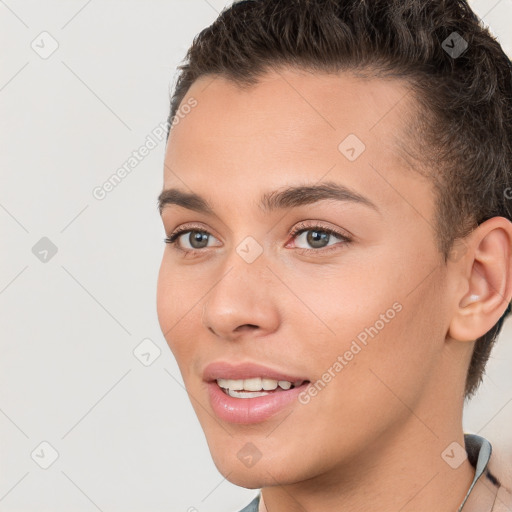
[202,255,280,341]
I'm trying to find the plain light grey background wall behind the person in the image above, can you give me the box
[0,0,512,512]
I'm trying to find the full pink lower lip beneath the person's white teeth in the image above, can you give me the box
[207,381,309,424]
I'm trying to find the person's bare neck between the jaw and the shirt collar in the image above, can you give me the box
[262,415,475,512]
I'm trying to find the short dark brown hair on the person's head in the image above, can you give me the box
[167,0,512,399]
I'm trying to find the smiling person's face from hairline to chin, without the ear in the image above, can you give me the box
[157,69,449,488]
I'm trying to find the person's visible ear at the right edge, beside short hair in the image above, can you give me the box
[448,217,512,341]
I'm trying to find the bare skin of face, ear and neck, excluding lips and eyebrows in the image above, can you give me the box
[157,68,512,512]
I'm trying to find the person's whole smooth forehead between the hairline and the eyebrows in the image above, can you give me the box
[164,68,432,226]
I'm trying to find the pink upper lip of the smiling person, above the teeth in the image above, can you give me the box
[203,361,308,382]
